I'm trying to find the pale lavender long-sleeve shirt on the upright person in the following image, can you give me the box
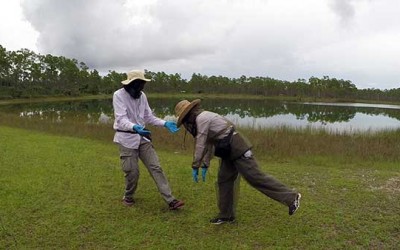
[113,88,165,149]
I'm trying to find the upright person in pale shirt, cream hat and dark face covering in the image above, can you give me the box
[113,70,184,210]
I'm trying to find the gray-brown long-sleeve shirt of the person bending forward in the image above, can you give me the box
[192,111,232,168]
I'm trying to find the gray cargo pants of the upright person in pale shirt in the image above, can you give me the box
[119,139,175,204]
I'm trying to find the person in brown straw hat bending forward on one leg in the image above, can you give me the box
[175,99,301,224]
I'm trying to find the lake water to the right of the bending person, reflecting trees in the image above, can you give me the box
[204,100,400,132]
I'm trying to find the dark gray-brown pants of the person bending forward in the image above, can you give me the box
[218,151,297,218]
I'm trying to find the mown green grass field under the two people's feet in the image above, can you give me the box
[0,126,400,249]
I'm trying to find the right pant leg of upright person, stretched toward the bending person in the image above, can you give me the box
[139,140,175,204]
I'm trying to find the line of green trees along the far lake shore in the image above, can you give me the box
[0,45,400,102]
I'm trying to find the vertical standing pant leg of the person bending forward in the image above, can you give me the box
[217,159,238,218]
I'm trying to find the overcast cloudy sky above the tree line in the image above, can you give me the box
[0,0,400,89]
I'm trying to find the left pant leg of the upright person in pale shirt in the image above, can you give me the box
[119,145,139,203]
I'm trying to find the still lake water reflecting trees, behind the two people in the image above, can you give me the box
[0,98,400,133]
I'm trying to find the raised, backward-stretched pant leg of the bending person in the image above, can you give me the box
[234,151,298,206]
